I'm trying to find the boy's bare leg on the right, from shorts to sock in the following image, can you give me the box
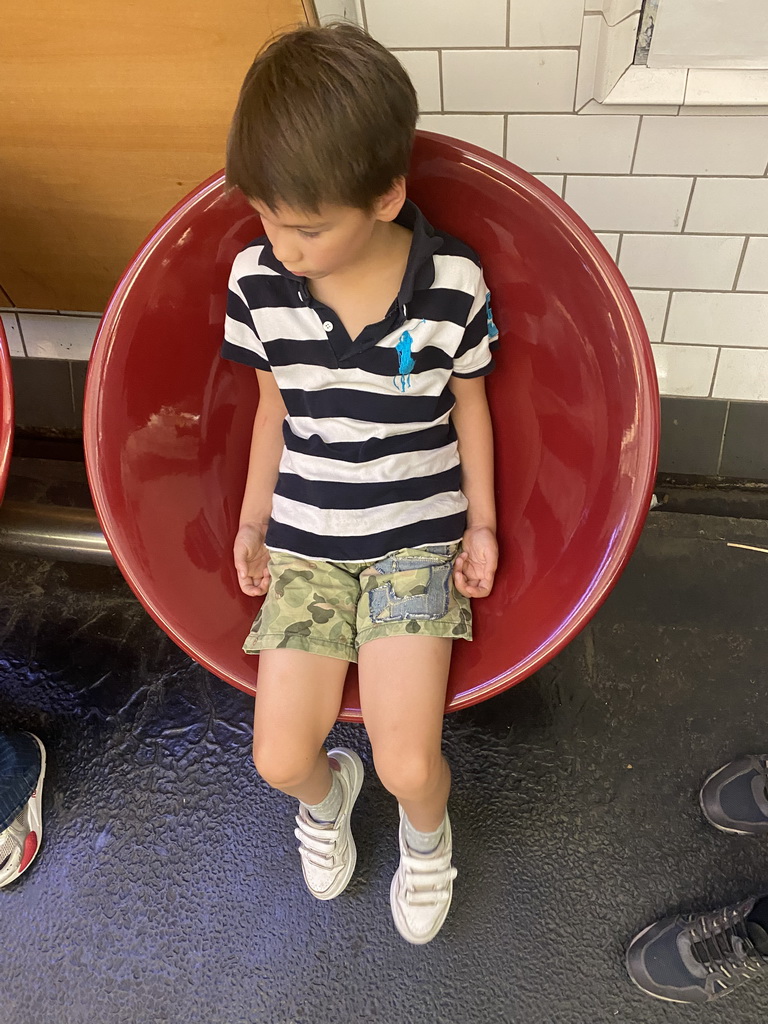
[358,635,453,833]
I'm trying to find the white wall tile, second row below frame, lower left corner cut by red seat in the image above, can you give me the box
[565,175,692,231]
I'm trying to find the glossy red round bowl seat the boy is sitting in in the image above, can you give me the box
[84,132,658,720]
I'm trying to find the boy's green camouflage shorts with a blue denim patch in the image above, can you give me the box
[243,544,472,662]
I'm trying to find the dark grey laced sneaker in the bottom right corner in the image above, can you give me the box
[627,896,768,1004]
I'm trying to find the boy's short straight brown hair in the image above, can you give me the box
[226,24,418,213]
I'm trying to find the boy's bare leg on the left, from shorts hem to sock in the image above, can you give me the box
[253,649,348,804]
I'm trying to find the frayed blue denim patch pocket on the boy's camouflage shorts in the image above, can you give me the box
[368,555,454,623]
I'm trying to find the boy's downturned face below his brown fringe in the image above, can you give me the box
[251,192,399,281]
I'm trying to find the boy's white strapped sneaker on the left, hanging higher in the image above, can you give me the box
[294,748,364,899]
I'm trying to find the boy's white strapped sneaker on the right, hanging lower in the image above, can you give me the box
[389,808,457,945]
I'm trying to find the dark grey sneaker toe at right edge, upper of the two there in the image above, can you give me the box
[698,754,768,836]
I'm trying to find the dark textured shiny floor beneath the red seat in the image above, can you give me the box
[0,512,768,1024]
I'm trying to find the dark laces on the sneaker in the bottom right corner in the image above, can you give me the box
[688,906,768,989]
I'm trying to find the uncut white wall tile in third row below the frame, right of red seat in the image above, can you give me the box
[618,234,743,291]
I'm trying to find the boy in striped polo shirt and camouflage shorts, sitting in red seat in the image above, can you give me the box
[222,25,498,943]
